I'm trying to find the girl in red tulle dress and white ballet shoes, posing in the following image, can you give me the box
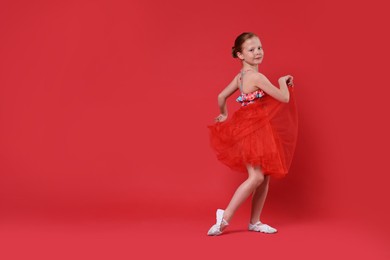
[208,32,297,236]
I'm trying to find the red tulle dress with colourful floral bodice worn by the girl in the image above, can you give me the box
[208,73,298,178]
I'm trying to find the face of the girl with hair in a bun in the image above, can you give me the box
[237,37,264,65]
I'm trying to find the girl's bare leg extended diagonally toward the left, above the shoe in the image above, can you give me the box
[223,165,264,225]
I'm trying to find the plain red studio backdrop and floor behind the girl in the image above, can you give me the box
[0,0,390,259]
